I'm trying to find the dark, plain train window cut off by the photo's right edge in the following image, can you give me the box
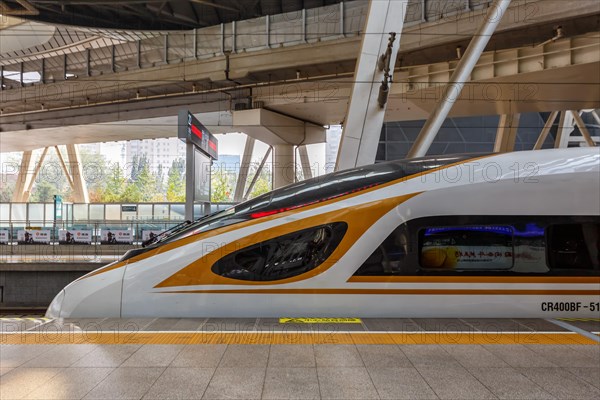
[547,223,600,270]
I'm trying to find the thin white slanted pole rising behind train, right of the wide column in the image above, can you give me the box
[407,0,511,158]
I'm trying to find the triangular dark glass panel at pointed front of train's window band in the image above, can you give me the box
[354,224,410,276]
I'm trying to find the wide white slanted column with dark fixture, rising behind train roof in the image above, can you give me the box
[335,0,408,170]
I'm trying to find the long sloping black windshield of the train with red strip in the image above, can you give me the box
[156,154,484,243]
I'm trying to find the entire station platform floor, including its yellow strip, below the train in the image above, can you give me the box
[0,316,600,400]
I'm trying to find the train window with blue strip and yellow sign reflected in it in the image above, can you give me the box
[419,225,514,271]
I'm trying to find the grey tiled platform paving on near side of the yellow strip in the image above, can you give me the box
[0,344,600,400]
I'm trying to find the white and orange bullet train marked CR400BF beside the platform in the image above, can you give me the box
[47,148,600,318]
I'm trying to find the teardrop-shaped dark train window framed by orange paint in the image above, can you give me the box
[212,222,348,281]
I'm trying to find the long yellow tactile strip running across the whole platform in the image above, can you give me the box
[0,331,598,346]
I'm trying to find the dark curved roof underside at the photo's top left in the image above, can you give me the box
[2,0,341,31]
